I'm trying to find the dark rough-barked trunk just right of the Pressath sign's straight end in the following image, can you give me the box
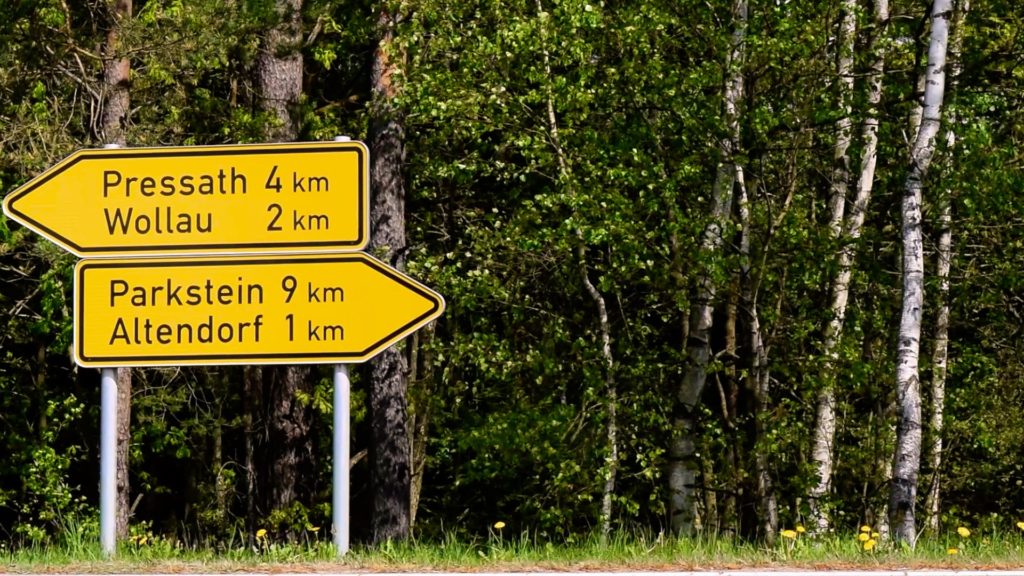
[370,2,412,543]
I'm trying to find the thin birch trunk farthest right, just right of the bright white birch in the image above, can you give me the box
[925,0,971,532]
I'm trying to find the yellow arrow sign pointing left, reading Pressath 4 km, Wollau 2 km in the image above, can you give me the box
[3,141,369,256]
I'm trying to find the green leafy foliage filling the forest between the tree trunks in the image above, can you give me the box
[0,0,1024,545]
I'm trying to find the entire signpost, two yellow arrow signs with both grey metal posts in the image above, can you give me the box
[3,136,444,558]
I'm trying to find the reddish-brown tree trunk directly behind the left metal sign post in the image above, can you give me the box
[98,0,132,538]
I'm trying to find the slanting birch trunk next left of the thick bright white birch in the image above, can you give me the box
[809,0,889,533]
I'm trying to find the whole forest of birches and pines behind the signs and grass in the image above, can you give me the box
[0,0,1024,545]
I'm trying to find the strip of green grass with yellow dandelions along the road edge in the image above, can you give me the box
[6,531,1024,573]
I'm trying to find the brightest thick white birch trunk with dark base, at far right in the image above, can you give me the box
[889,0,952,546]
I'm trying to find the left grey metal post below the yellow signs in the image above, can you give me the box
[99,368,118,558]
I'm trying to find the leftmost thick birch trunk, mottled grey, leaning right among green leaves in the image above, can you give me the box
[668,0,746,535]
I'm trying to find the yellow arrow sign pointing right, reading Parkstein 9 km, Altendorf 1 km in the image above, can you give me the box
[75,252,444,367]
